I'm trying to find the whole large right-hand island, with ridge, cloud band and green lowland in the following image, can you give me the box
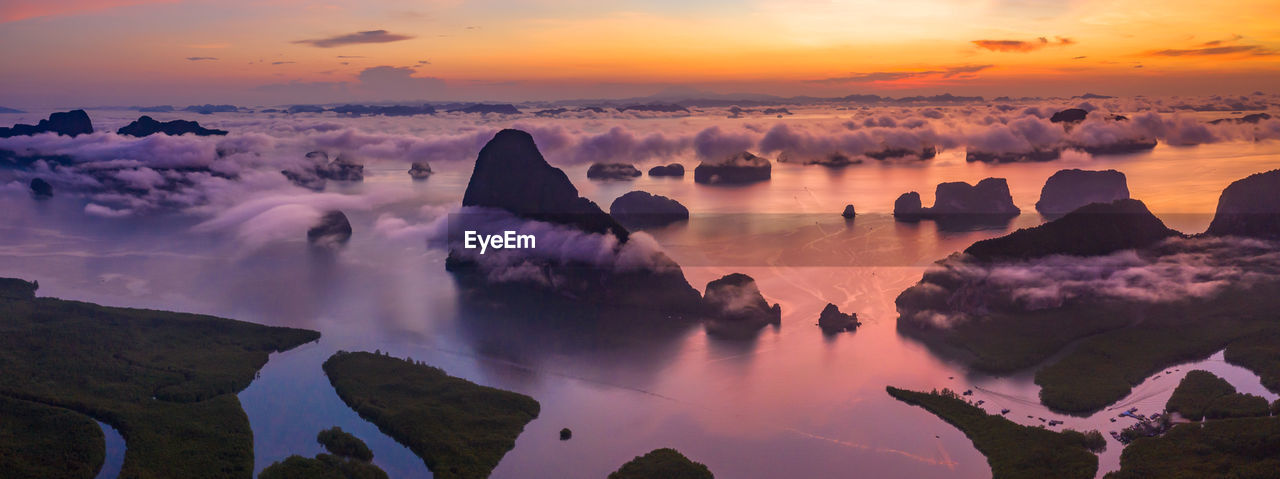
[897,172,1280,412]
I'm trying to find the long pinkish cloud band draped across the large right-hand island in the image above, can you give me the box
[902,238,1280,328]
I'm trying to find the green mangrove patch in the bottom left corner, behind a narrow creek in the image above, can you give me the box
[0,396,106,479]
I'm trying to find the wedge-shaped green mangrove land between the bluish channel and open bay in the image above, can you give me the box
[324,351,540,479]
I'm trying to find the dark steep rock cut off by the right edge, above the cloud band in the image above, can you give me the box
[1206,169,1280,240]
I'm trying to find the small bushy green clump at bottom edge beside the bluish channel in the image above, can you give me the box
[257,426,387,479]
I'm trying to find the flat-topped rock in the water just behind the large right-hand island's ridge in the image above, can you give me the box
[1036,169,1129,218]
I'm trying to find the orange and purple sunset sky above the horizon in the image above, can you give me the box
[0,0,1280,108]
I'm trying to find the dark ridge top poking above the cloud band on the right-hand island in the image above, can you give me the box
[964,200,1181,260]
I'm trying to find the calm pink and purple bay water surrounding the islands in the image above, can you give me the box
[0,137,1280,478]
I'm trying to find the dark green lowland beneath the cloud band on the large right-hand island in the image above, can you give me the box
[899,277,1280,414]
